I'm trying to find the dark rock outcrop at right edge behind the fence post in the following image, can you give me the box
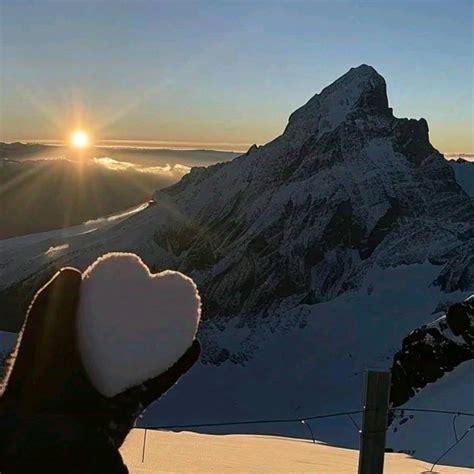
[390,297,474,406]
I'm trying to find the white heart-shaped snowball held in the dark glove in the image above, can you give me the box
[77,253,201,397]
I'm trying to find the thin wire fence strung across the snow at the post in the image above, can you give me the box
[142,408,474,472]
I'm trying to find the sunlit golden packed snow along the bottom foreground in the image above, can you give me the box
[120,429,473,474]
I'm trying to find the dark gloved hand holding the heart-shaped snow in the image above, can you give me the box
[0,268,200,474]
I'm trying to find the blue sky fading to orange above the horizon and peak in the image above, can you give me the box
[0,0,474,153]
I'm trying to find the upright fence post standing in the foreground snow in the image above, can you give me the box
[359,370,390,474]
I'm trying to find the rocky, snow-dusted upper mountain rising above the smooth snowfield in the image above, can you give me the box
[154,66,474,326]
